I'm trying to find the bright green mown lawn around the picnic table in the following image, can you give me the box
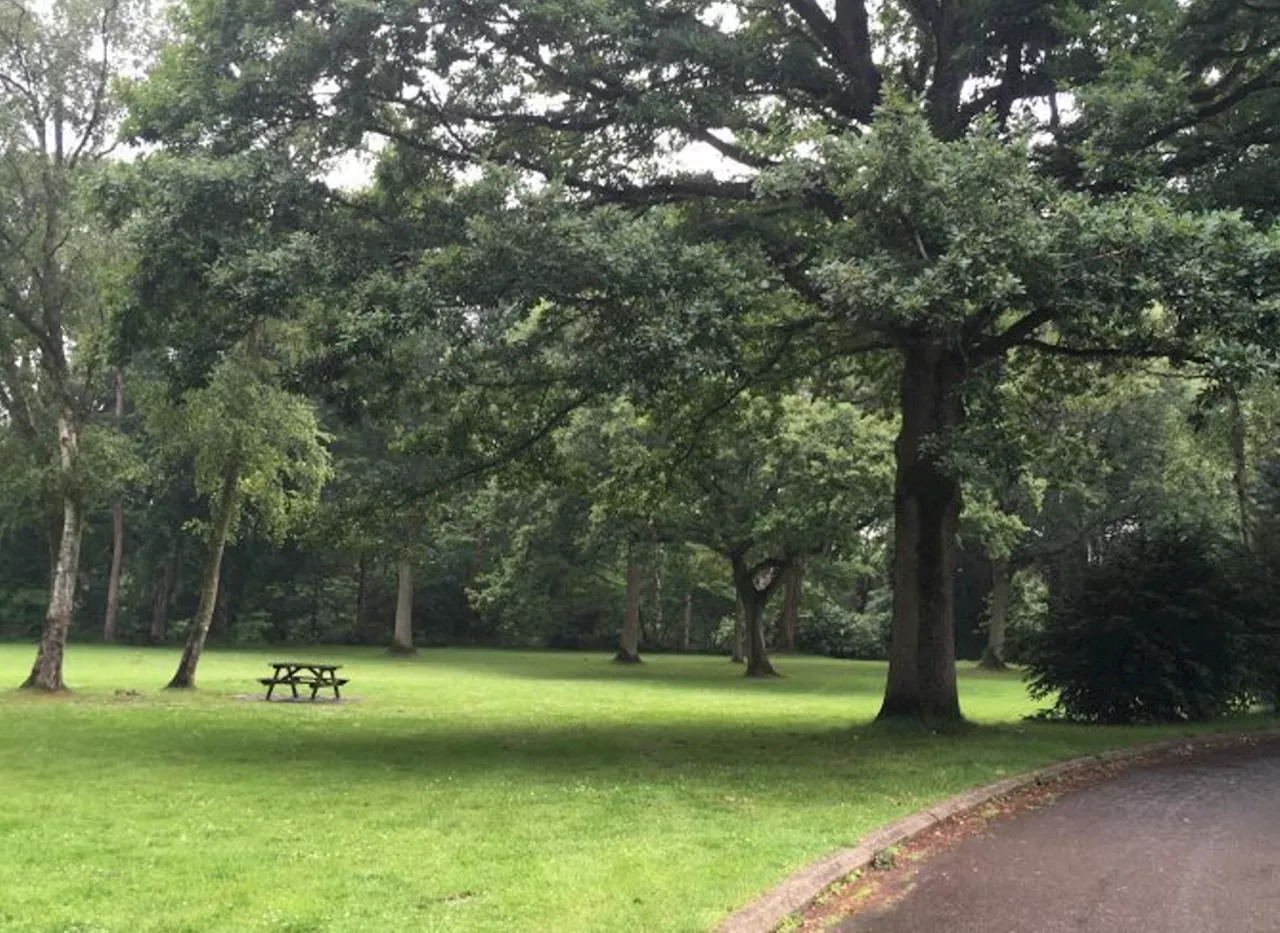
[0,645,1269,933]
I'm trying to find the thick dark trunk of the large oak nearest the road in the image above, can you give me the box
[878,340,965,721]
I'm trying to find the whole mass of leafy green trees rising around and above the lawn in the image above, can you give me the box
[0,0,1280,719]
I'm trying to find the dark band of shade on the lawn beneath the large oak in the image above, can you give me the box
[80,717,1277,795]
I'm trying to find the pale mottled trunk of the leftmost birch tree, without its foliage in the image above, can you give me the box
[22,406,84,691]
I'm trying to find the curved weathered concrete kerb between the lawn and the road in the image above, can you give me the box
[714,730,1280,933]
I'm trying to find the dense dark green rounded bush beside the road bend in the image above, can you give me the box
[1027,529,1274,723]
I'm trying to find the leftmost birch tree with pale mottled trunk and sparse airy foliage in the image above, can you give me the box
[0,0,143,691]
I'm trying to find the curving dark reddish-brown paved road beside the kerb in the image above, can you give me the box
[836,742,1280,933]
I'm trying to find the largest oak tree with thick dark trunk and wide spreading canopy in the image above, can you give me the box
[129,0,1276,719]
